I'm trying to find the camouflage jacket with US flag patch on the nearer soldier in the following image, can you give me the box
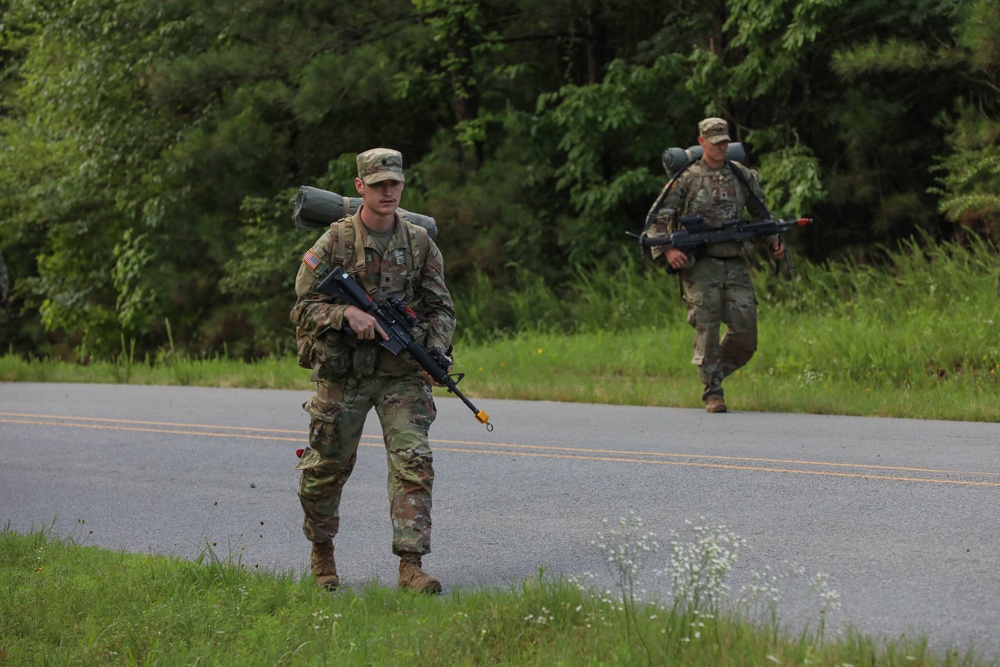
[289,211,455,380]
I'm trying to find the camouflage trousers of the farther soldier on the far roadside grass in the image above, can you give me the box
[681,257,757,400]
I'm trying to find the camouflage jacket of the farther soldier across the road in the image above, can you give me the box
[647,160,778,259]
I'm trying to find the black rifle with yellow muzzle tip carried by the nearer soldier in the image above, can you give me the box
[315,266,493,431]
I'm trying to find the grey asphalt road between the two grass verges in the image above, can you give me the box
[0,383,1000,659]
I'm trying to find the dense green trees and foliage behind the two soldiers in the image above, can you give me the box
[0,0,1000,360]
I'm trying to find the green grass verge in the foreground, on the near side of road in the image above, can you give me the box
[0,530,987,667]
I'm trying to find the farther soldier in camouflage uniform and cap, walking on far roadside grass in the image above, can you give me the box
[646,118,785,412]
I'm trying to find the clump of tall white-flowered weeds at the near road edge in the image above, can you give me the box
[594,511,840,665]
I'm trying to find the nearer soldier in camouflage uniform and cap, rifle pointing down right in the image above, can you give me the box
[290,148,455,593]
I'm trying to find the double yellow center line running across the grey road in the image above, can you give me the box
[0,412,1000,487]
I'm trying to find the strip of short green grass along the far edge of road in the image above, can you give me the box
[0,326,1000,422]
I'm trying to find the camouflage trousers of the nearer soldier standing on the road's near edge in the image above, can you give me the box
[296,374,437,555]
